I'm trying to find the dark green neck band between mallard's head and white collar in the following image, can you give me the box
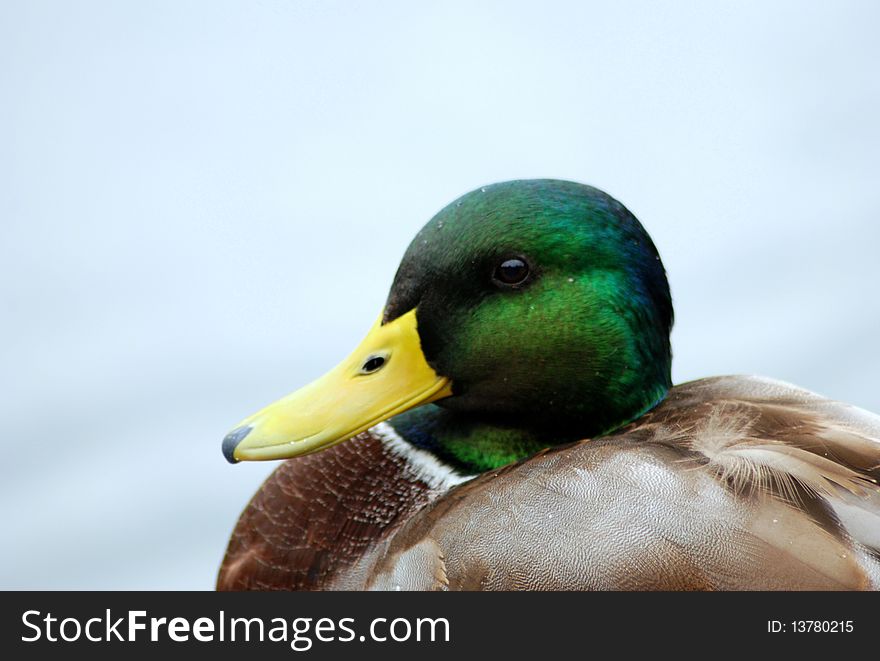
[388,388,667,475]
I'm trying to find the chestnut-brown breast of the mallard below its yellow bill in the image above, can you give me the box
[217,432,437,590]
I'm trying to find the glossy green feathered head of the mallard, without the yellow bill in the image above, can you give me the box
[384,179,672,438]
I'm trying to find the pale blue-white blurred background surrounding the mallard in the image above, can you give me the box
[0,0,880,590]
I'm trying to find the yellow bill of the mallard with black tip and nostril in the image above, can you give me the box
[223,309,452,463]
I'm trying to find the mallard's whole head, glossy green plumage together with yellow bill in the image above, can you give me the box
[223,180,672,462]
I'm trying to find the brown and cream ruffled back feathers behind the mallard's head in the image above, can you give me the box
[644,377,880,552]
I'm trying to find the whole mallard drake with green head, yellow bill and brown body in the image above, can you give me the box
[217,179,880,590]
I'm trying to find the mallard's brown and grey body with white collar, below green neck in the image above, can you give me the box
[218,377,880,590]
